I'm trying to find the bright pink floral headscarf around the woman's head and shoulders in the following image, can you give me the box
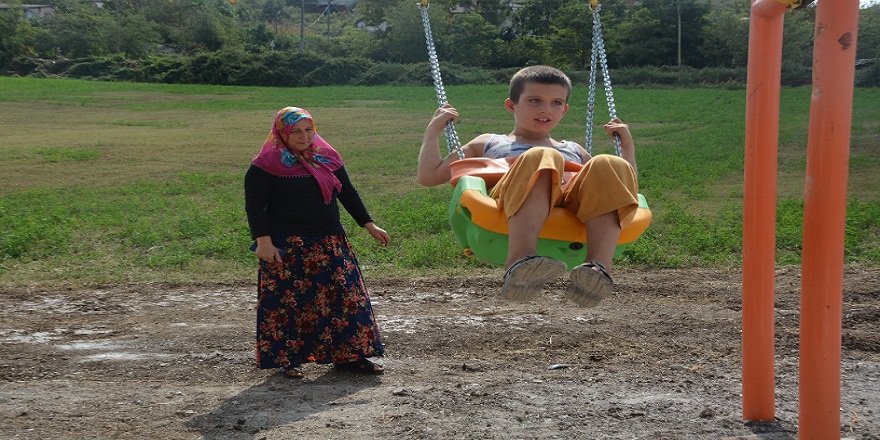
[252,107,342,203]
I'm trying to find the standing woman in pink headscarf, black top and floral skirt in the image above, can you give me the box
[244,107,391,378]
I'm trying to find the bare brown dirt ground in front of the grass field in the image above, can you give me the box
[0,267,880,440]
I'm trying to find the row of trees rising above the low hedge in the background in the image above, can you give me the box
[0,0,880,84]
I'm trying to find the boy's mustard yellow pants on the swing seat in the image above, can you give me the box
[491,147,639,228]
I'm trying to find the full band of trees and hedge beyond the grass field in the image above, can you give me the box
[0,0,880,87]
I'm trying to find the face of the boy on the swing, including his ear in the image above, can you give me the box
[504,83,568,133]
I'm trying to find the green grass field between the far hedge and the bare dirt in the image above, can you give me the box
[0,78,880,286]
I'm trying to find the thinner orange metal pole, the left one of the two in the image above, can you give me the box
[742,0,785,420]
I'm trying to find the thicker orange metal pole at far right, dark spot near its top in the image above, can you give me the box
[799,0,859,439]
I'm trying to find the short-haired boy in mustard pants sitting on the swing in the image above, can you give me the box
[418,66,639,307]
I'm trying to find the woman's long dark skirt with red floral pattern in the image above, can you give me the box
[251,235,384,368]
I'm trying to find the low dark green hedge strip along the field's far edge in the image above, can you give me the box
[5,55,764,88]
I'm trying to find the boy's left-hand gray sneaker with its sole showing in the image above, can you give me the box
[501,255,566,301]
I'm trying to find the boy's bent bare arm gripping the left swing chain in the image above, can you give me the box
[418,105,486,186]
